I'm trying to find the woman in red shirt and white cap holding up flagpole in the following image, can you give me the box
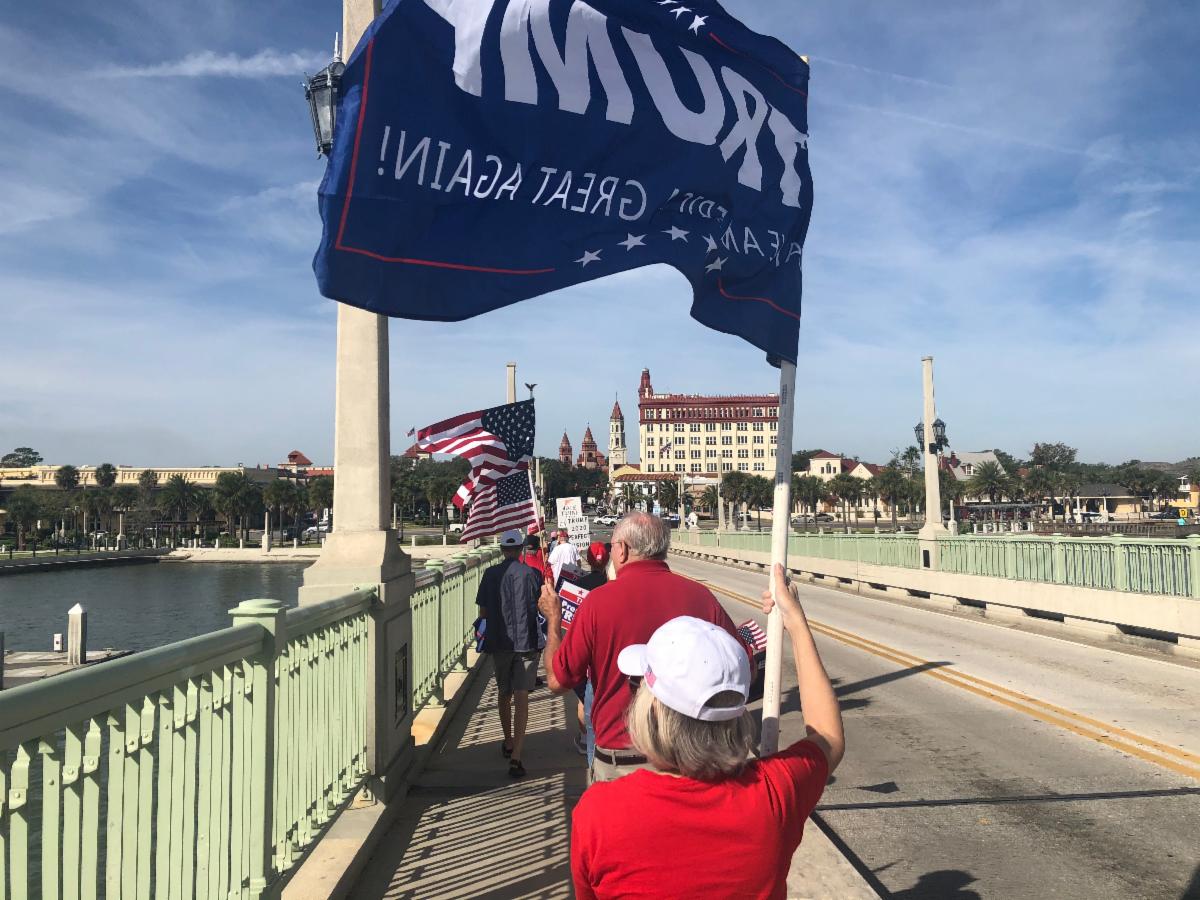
[571,566,845,898]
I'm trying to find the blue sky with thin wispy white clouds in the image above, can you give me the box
[0,0,1200,466]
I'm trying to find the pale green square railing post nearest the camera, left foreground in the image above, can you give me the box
[230,600,287,900]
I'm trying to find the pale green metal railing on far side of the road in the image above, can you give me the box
[677,532,1200,599]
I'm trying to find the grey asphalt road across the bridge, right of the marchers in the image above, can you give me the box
[671,557,1200,900]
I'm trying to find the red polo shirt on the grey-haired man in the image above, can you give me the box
[553,559,740,750]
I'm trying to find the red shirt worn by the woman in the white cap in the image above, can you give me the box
[571,740,829,900]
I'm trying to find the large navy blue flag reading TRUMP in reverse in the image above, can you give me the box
[313,0,812,361]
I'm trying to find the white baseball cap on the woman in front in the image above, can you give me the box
[617,616,750,722]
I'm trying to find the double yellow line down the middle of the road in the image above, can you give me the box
[703,582,1200,780]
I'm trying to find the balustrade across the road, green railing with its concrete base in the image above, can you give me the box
[672,532,1200,656]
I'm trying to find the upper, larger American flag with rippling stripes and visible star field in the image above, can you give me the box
[416,400,534,509]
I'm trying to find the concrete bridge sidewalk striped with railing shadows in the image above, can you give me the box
[350,659,877,900]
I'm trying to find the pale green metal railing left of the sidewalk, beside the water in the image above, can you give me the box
[0,548,497,900]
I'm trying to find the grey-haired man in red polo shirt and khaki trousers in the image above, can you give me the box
[538,512,737,781]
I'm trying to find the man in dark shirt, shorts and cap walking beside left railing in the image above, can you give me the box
[475,530,545,778]
